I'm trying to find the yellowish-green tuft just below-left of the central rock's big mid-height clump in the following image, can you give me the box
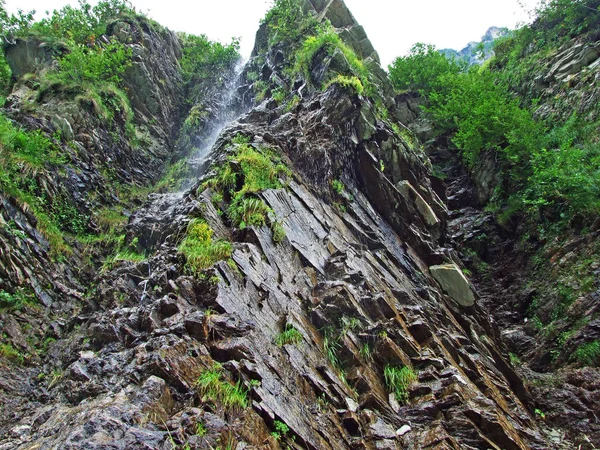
[179,219,233,274]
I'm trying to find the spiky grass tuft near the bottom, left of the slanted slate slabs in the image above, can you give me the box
[196,364,248,410]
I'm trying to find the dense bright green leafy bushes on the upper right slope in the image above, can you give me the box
[390,39,600,225]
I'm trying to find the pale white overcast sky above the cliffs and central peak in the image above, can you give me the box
[6,0,537,67]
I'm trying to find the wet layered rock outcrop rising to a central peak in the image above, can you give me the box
[0,0,568,449]
